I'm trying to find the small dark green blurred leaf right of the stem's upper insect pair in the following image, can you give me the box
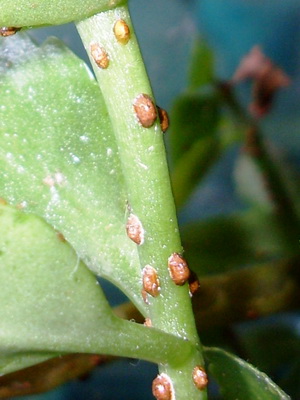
[170,92,220,165]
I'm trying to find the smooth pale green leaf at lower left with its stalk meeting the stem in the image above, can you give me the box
[0,205,192,374]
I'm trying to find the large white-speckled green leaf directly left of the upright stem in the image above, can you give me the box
[0,34,145,311]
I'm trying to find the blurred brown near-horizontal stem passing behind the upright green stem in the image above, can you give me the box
[114,257,300,331]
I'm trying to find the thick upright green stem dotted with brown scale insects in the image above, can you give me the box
[77,6,206,400]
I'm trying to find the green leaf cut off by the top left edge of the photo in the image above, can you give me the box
[0,0,126,27]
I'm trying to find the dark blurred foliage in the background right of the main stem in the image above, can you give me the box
[170,32,300,399]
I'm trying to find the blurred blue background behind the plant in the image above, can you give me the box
[18,0,300,400]
